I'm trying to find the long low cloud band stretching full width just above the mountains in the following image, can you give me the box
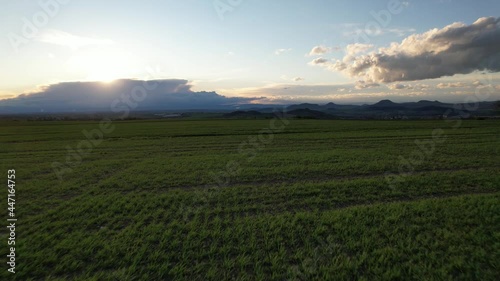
[0,77,500,114]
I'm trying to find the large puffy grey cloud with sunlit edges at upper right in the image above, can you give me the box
[312,17,500,83]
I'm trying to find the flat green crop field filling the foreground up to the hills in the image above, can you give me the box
[0,119,500,280]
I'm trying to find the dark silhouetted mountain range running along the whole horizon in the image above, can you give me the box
[0,100,500,120]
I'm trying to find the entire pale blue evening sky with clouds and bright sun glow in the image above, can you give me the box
[0,0,500,109]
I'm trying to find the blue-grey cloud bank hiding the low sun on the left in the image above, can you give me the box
[0,79,256,114]
